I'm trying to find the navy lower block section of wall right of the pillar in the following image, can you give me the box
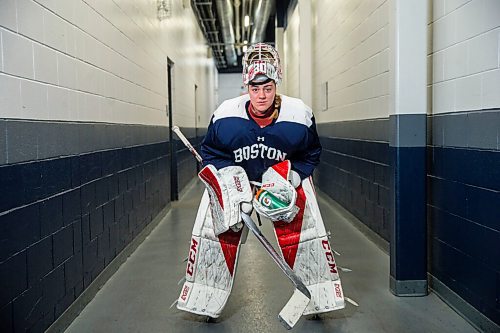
[427,146,500,324]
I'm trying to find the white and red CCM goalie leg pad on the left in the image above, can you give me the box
[177,191,242,318]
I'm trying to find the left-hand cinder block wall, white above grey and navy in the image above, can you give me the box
[0,0,216,332]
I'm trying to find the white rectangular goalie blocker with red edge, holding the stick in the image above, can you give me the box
[198,164,252,236]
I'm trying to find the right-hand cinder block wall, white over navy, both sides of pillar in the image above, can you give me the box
[282,0,500,328]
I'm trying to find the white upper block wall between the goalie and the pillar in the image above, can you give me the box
[313,0,389,123]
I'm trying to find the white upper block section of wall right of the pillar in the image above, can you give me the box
[428,0,500,115]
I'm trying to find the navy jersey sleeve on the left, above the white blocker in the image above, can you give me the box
[201,118,234,169]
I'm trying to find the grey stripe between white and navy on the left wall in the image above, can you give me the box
[0,119,168,165]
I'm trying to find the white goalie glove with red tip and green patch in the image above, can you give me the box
[253,160,300,222]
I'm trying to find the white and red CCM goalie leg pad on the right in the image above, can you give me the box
[274,178,345,315]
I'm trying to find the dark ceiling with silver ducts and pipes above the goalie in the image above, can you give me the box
[191,0,280,73]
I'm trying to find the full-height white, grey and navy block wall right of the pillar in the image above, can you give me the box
[427,0,500,324]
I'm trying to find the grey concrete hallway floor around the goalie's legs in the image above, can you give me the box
[66,182,476,333]
